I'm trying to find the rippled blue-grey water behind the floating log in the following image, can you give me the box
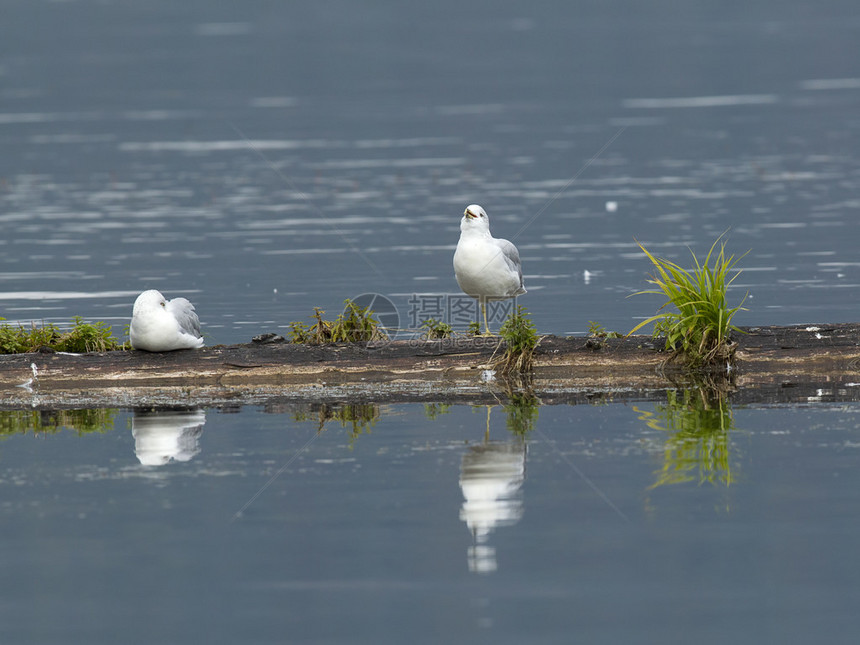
[0,0,860,344]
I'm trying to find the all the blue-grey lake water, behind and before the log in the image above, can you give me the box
[0,0,860,644]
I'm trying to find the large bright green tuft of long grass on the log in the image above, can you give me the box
[628,235,746,368]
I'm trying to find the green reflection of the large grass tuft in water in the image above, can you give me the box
[634,388,736,489]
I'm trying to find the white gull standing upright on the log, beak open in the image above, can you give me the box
[454,204,526,336]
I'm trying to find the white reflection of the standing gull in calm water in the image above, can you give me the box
[460,406,527,573]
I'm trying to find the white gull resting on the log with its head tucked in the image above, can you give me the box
[128,289,203,352]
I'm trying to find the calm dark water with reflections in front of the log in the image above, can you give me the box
[0,393,860,643]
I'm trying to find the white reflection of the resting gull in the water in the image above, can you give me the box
[131,409,206,466]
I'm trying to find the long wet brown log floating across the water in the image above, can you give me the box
[0,324,860,409]
